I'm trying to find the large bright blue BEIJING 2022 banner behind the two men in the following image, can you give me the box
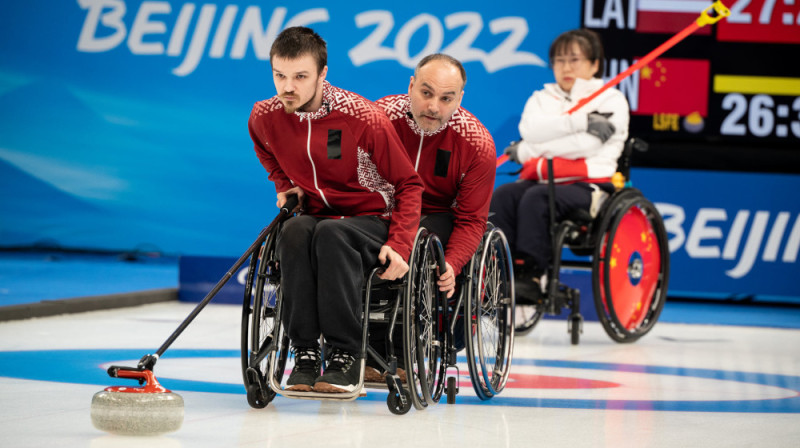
[0,0,580,255]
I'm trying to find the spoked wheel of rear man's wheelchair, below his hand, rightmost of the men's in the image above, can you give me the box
[464,229,515,400]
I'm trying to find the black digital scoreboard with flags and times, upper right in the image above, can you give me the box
[582,0,800,173]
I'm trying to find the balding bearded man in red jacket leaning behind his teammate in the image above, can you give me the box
[367,53,497,381]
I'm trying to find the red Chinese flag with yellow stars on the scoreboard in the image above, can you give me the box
[631,59,710,117]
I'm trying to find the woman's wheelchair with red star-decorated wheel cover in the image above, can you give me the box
[516,138,669,344]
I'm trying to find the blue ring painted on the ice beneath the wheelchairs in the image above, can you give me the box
[0,349,800,413]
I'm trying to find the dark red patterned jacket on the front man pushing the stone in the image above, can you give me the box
[248,81,423,260]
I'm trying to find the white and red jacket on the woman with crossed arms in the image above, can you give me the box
[517,78,630,183]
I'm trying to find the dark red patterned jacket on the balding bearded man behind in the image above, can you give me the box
[377,94,497,273]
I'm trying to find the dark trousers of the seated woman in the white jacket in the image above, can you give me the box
[489,180,593,277]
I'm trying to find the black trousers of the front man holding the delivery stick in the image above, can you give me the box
[277,215,389,354]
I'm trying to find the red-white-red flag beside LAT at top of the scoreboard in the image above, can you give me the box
[636,0,712,34]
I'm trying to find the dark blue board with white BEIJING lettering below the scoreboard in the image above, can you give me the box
[631,168,800,300]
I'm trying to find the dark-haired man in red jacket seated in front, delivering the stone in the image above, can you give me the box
[248,27,423,392]
